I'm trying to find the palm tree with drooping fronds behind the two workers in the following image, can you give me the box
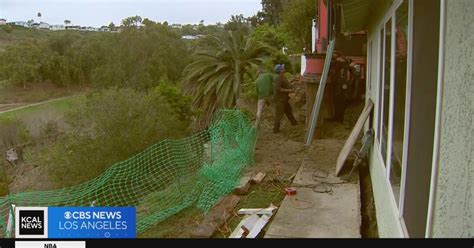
[184,31,270,124]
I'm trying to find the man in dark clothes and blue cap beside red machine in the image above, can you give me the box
[273,64,298,133]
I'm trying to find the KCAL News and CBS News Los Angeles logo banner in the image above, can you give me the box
[15,207,136,239]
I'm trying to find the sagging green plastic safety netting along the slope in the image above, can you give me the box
[0,110,257,235]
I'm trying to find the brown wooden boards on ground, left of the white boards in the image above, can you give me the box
[191,195,240,238]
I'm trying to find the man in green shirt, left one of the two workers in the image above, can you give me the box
[255,70,273,128]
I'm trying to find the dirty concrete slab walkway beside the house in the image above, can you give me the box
[265,157,361,238]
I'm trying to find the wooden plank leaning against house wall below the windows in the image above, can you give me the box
[336,99,374,176]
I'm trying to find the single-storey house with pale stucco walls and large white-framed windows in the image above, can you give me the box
[320,0,474,238]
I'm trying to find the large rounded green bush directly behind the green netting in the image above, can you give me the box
[41,86,192,187]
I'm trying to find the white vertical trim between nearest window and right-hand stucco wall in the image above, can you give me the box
[425,0,446,238]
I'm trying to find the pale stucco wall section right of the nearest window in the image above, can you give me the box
[432,0,474,238]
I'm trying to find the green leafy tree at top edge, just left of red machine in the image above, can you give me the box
[282,0,316,52]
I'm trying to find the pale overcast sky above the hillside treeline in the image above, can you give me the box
[0,0,261,27]
